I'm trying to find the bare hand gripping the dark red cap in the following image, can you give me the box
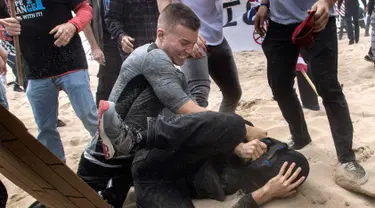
[309,0,330,33]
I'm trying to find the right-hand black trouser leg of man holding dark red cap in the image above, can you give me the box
[301,18,355,163]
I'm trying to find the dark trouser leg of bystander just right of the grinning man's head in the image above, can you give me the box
[207,39,242,113]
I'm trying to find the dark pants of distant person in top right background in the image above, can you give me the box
[345,5,359,43]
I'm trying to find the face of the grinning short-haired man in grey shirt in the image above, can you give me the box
[158,25,198,66]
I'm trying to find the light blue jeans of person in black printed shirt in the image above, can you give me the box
[26,70,98,161]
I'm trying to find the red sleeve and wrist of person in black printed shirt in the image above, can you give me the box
[68,0,93,33]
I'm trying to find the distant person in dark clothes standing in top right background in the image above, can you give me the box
[338,0,367,45]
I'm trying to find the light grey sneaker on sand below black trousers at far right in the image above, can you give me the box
[341,161,368,185]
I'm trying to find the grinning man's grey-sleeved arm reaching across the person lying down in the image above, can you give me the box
[142,49,208,114]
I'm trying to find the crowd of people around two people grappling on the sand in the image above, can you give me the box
[0,0,374,208]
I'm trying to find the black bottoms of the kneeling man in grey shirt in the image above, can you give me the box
[77,154,133,208]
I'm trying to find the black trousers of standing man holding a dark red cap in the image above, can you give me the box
[262,17,355,162]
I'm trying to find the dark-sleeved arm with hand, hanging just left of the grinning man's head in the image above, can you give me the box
[104,0,127,45]
